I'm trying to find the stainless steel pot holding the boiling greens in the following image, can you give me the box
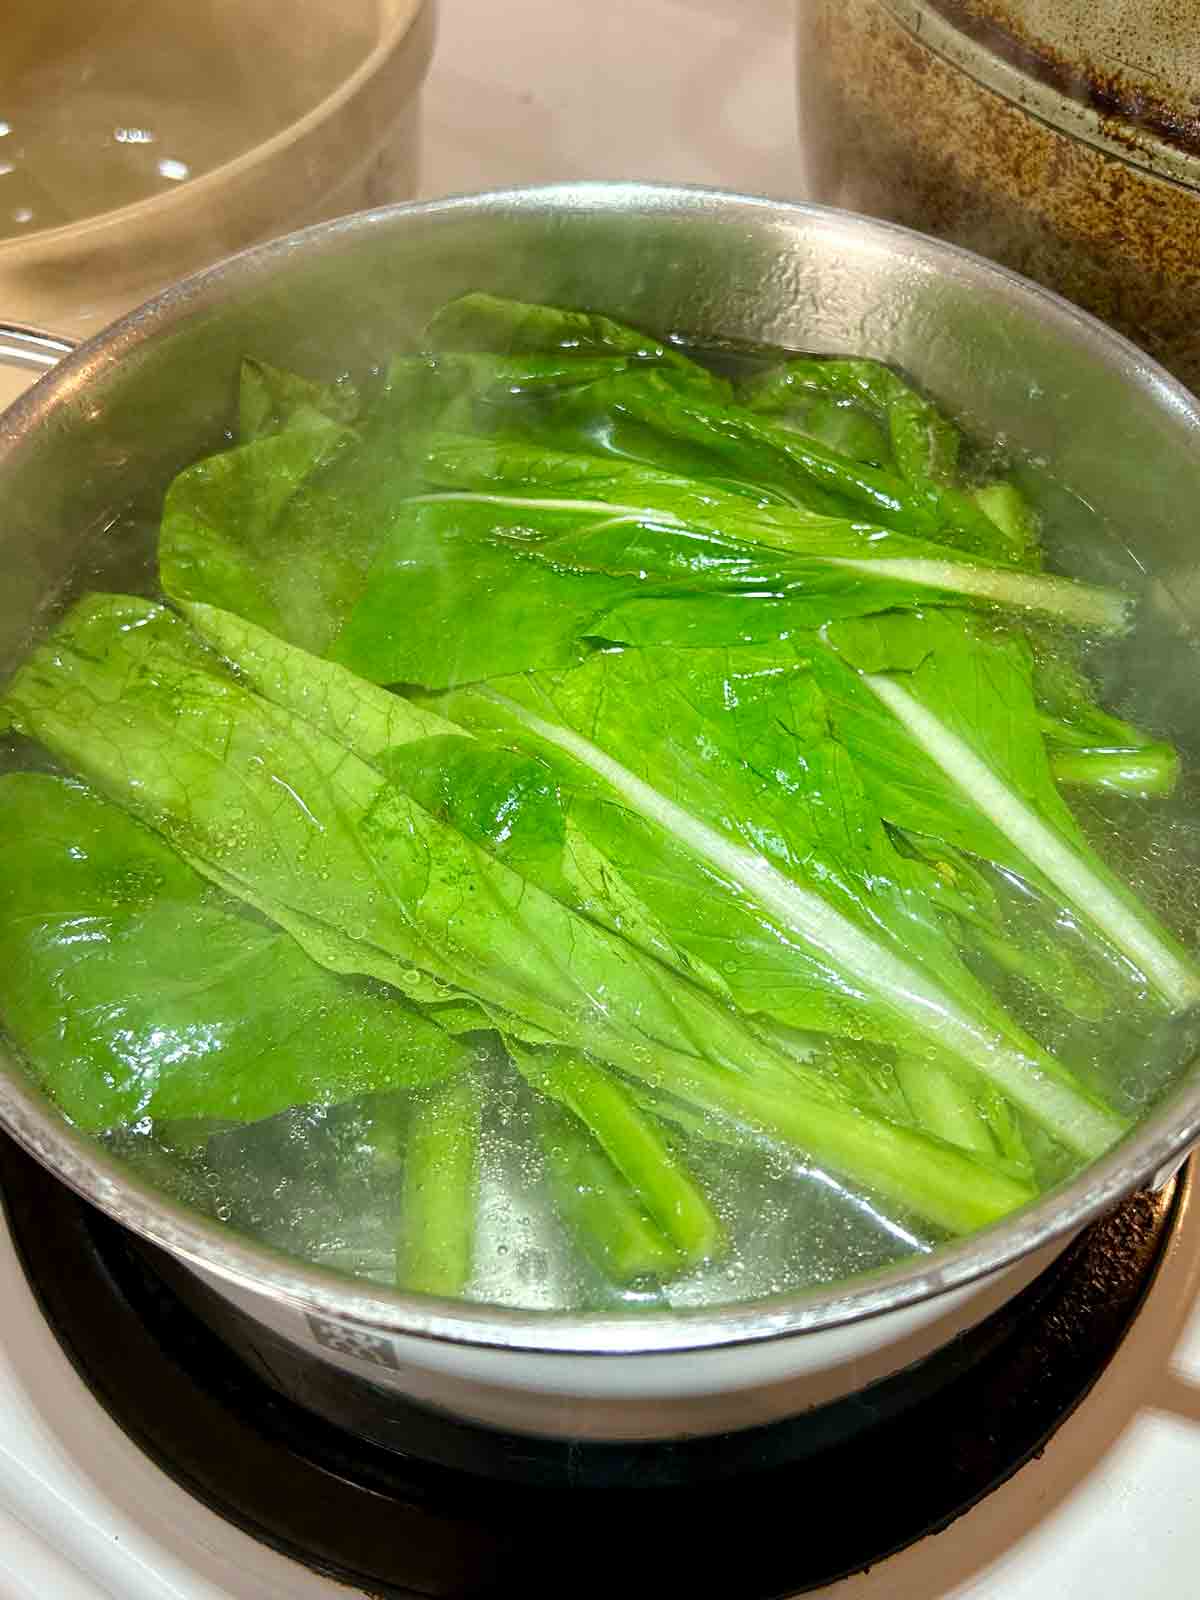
[0,184,1200,1438]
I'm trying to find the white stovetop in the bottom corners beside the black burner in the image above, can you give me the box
[0,1177,1200,1600]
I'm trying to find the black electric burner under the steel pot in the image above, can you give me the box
[0,1136,1178,1600]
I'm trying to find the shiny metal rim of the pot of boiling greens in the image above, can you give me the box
[0,182,1200,1357]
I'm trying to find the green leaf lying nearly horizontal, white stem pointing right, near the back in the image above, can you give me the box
[331,483,1125,688]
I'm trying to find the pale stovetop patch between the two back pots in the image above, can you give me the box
[421,0,803,198]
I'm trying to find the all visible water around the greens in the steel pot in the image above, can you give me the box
[0,344,1200,1310]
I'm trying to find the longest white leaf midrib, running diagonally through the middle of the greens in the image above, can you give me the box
[480,688,1123,1157]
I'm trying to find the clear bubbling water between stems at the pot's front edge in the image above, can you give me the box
[112,1054,936,1310]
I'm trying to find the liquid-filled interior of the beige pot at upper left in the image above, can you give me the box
[0,0,379,238]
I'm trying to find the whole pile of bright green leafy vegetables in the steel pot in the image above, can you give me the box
[0,294,1200,1304]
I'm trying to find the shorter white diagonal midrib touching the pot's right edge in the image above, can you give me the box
[862,674,1200,1010]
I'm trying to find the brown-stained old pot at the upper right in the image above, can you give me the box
[798,0,1200,389]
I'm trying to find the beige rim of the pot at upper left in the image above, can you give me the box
[0,0,434,270]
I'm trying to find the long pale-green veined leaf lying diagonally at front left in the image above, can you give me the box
[8,597,1049,1227]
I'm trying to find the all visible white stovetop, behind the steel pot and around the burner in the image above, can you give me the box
[0,0,1200,1600]
